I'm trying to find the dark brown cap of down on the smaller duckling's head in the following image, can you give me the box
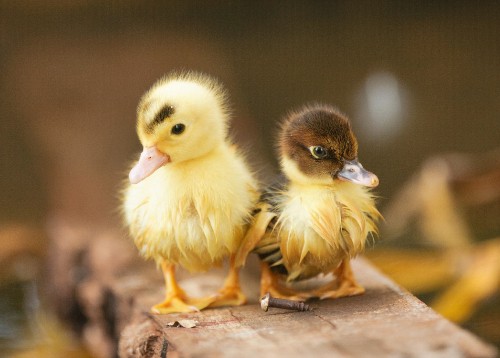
[279,104,358,176]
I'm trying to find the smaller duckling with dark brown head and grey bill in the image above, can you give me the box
[237,104,381,299]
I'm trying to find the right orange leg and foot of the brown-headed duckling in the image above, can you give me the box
[313,259,365,299]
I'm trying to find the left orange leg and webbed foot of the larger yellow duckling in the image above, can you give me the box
[151,262,210,314]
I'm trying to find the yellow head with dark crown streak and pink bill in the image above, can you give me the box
[129,72,229,184]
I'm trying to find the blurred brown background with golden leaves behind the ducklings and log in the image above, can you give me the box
[0,0,500,356]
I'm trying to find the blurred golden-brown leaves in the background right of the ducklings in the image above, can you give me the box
[370,148,500,330]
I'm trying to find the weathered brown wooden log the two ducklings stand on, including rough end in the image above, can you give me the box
[49,226,496,357]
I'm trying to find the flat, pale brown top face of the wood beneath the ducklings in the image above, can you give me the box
[145,259,495,357]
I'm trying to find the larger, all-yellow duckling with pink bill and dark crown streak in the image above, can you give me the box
[123,72,259,314]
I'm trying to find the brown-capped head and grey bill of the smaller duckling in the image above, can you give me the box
[279,104,379,187]
